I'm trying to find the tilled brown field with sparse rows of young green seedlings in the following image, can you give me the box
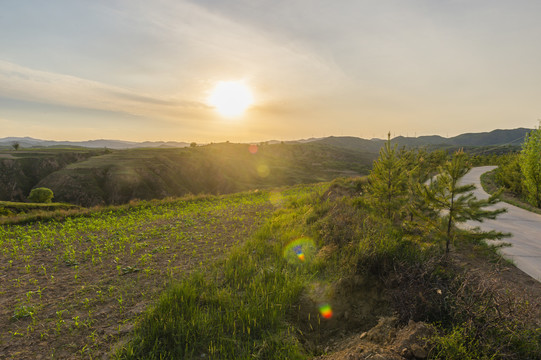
[0,192,273,359]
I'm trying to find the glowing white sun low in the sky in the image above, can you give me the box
[207,81,254,117]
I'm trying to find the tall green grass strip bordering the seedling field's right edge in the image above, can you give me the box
[115,187,324,359]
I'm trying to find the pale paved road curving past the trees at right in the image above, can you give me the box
[461,166,541,282]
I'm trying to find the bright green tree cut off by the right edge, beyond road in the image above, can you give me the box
[519,127,541,207]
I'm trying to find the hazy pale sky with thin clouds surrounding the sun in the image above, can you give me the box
[0,0,541,143]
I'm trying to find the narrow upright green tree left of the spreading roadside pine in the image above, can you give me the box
[369,132,407,220]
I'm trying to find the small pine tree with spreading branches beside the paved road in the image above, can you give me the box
[420,150,508,253]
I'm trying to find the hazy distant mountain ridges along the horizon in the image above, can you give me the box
[0,128,532,152]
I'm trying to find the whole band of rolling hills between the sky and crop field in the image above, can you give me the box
[0,128,530,206]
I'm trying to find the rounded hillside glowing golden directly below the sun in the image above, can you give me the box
[31,143,376,206]
